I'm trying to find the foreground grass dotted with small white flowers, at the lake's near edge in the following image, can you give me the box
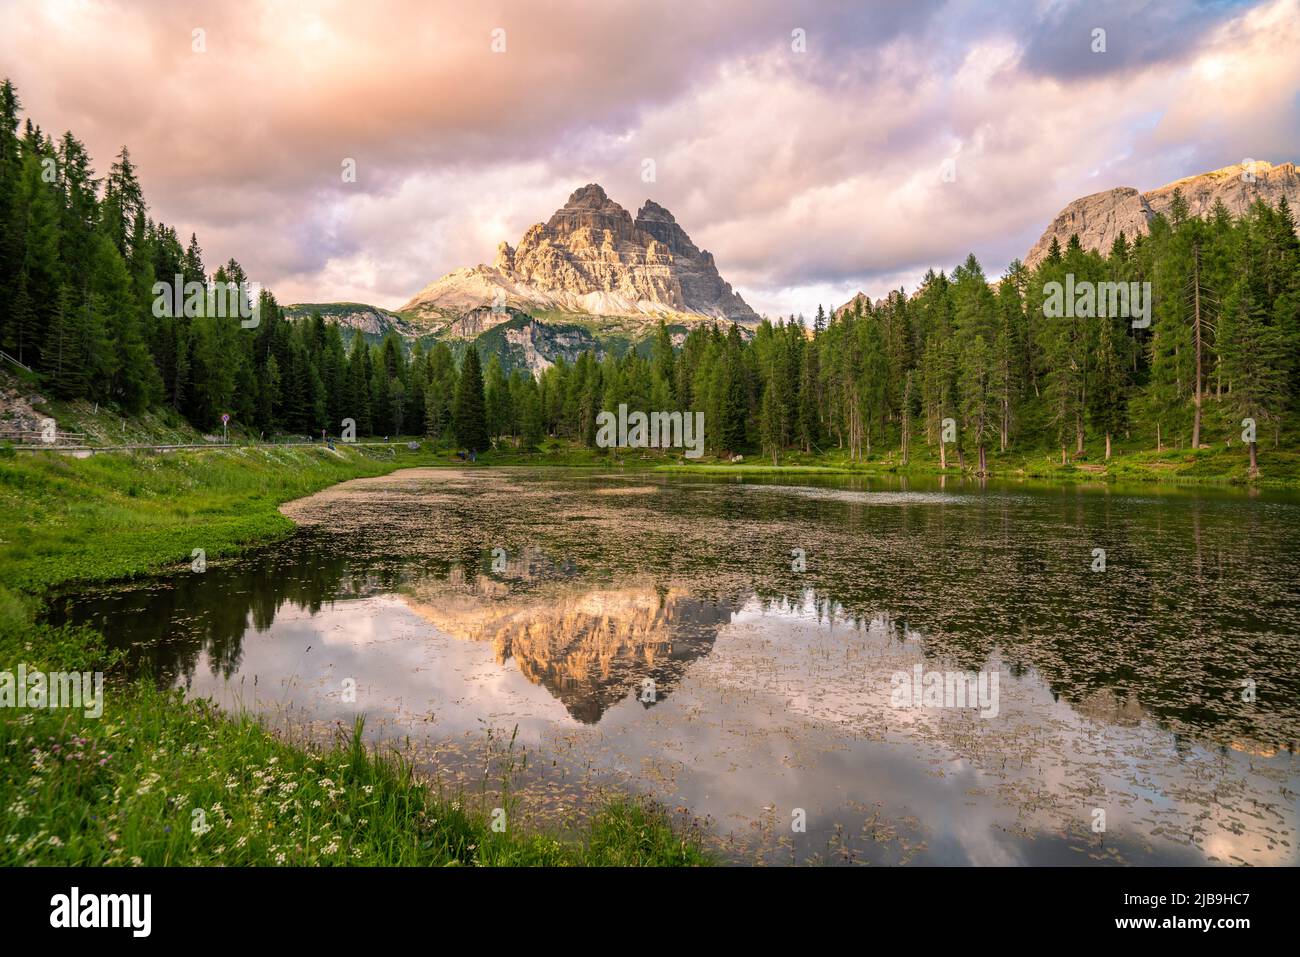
[0,684,707,866]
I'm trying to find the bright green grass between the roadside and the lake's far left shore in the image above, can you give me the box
[0,445,434,592]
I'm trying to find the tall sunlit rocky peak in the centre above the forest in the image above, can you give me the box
[402,183,758,322]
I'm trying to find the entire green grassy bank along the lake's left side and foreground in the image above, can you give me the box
[0,446,706,865]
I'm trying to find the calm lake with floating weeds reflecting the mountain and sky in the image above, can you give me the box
[55,469,1300,865]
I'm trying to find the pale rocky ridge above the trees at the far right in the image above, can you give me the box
[1024,161,1300,268]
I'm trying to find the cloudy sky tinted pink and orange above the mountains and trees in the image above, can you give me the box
[0,0,1300,315]
